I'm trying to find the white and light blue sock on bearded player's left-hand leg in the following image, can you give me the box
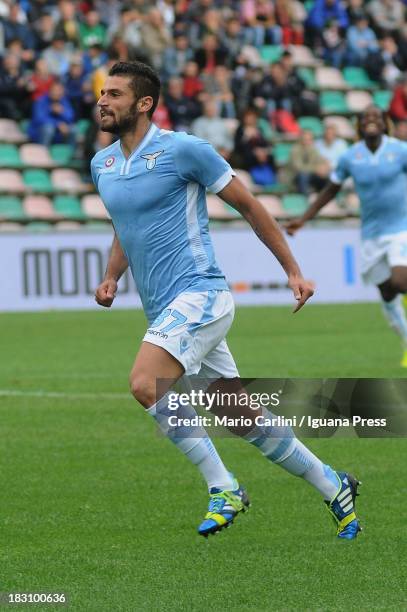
[147,392,233,491]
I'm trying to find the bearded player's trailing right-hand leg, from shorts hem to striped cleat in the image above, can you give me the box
[200,341,360,539]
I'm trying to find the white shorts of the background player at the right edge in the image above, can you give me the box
[362,232,407,285]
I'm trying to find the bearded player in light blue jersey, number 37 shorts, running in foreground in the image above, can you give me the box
[91,62,360,539]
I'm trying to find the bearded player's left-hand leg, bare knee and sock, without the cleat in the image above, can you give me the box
[130,342,233,489]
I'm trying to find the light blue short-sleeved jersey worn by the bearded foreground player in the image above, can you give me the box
[91,124,234,323]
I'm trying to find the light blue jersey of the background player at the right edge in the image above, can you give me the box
[331,136,407,239]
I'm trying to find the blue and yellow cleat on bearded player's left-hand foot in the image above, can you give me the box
[198,479,250,538]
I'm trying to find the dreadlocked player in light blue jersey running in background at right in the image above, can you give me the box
[286,106,407,368]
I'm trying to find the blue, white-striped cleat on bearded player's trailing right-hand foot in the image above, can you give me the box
[325,472,362,540]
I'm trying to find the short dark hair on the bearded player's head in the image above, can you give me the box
[109,62,161,119]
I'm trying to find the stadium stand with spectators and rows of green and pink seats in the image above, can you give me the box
[0,0,407,231]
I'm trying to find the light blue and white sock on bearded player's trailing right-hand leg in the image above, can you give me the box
[245,409,340,501]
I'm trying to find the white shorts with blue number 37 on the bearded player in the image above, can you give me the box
[143,290,239,378]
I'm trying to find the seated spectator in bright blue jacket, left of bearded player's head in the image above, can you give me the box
[28,81,75,146]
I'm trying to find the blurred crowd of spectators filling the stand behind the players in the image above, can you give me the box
[0,0,407,193]
